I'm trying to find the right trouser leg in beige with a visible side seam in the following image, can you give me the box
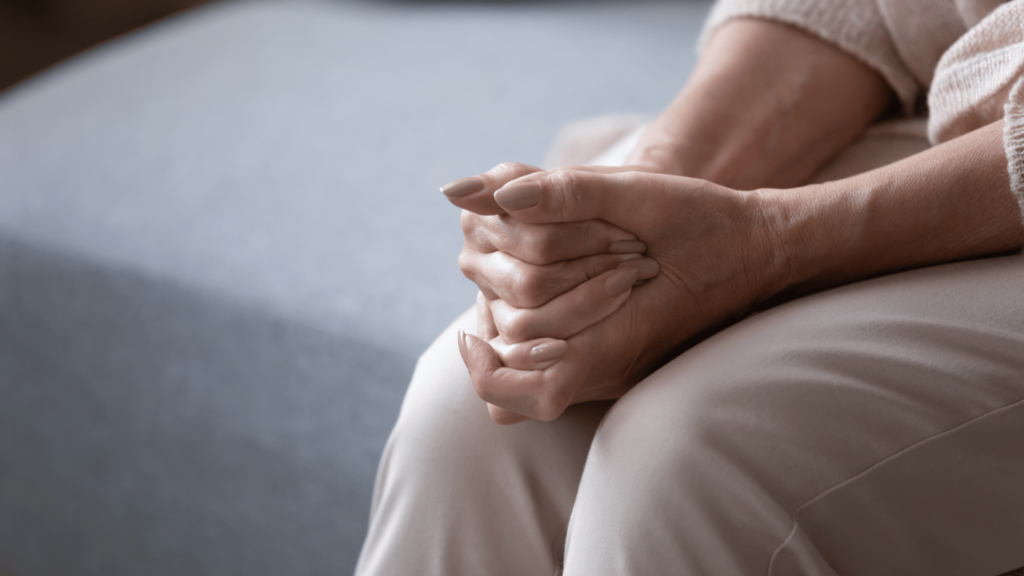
[565,256,1024,576]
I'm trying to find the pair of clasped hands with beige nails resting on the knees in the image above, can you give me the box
[442,163,785,423]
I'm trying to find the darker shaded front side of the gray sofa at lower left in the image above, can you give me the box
[0,235,412,576]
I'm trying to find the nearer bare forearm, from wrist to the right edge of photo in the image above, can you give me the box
[770,121,1024,291]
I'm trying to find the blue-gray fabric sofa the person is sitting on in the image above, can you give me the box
[0,1,708,576]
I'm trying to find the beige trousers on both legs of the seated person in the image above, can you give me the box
[356,118,1024,576]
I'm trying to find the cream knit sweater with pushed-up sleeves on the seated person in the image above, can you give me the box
[703,0,1024,221]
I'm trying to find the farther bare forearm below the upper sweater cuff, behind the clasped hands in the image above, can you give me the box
[628,19,892,190]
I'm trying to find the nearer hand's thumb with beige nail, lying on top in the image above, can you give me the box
[494,166,684,224]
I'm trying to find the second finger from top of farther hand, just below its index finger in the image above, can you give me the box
[459,252,657,307]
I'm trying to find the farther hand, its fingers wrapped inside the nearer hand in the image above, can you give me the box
[442,163,657,423]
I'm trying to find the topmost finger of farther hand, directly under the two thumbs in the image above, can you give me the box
[460,211,647,264]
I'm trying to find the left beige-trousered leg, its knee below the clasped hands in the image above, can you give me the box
[356,310,607,576]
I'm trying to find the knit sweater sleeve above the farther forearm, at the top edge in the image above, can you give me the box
[700,0,922,114]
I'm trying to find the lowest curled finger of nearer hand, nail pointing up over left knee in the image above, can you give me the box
[459,331,571,421]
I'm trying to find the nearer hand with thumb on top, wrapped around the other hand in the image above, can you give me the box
[452,169,785,421]
